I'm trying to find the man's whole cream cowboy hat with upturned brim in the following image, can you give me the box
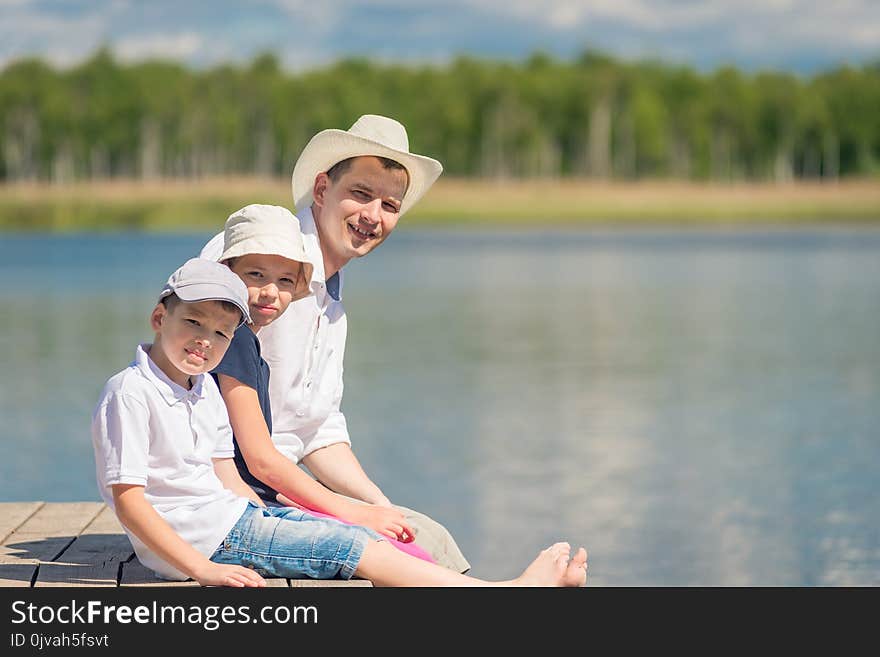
[291,114,443,215]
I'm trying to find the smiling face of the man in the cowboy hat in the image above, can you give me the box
[314,156,407,273]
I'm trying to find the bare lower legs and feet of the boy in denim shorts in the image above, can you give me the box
[355,541,587,586]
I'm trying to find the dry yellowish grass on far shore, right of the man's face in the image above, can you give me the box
[421,180,880,224]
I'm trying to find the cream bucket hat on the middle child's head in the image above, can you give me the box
[219,203,314,282]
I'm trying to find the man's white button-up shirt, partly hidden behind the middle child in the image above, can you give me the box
[199,208,351,463]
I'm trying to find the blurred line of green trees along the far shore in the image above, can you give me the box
[0,49,880,182]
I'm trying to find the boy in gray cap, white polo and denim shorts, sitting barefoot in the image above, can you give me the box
[92,258,586,587]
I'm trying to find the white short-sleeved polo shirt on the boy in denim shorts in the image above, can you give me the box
[92,345,248,580]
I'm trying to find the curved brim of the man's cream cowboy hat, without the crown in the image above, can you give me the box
[290,129,443,215]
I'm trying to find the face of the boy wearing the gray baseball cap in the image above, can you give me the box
[150,301,241,387]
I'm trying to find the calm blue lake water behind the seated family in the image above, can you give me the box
[0,228,880,586]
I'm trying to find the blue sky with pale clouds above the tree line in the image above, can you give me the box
[0,0,880,74]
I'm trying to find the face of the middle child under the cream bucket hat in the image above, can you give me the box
[231,253,309,329]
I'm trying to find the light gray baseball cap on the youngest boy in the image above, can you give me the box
[159,258,251,326]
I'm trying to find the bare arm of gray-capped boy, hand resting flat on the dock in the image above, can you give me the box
[112,484,266,587]
